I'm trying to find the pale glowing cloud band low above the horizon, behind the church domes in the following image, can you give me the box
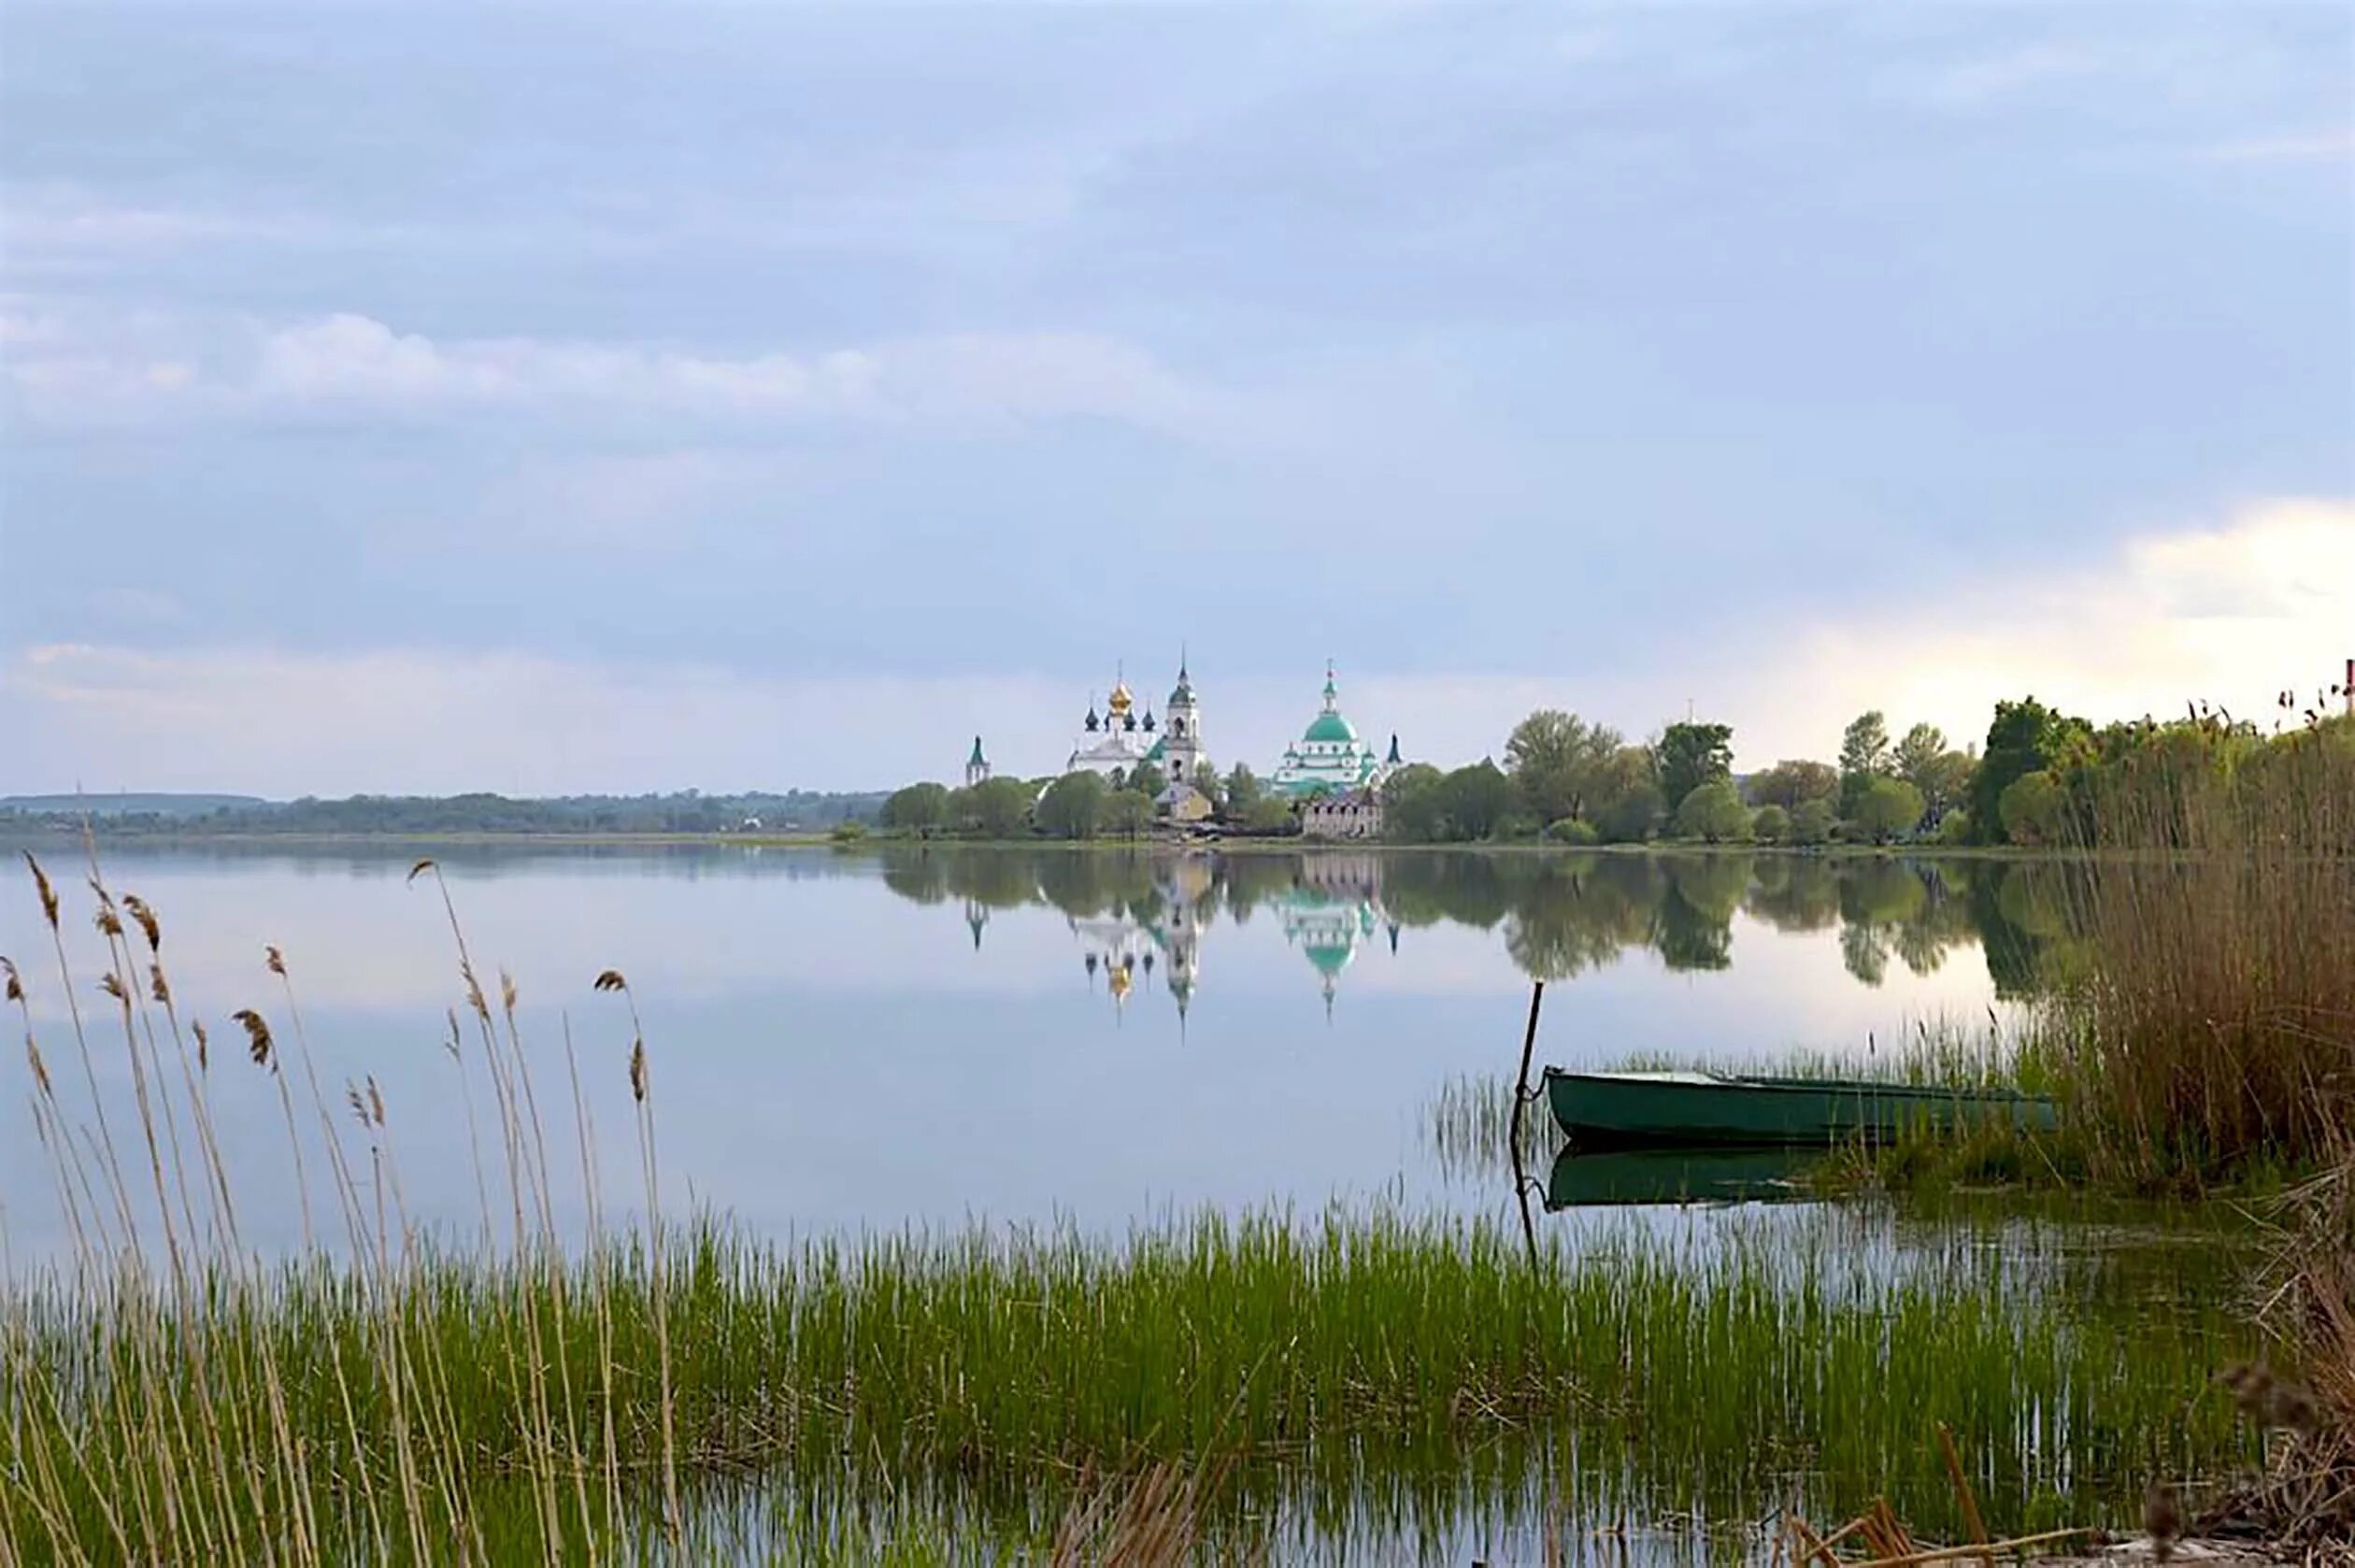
[0,499,2355,796]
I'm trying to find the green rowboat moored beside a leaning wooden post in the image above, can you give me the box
[1545,1066,2056,1147]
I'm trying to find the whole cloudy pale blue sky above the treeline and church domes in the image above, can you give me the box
[0,0,2355,796]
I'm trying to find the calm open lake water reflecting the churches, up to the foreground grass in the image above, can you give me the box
[0,848,2081,1257]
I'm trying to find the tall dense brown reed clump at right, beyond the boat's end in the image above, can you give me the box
[2039,720,2355,1187]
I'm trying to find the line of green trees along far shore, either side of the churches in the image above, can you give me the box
[0,685,2355,855]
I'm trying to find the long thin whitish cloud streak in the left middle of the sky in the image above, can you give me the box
[0,311,1249,434]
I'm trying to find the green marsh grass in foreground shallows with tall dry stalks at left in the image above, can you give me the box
[0,862,2245,1568]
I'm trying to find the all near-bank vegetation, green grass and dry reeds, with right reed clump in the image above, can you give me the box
[0,706,2355,1568]
